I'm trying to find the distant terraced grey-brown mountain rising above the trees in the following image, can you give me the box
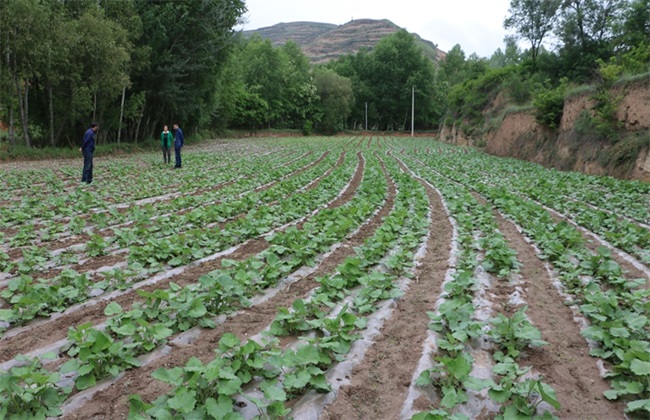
[243,19,446,64]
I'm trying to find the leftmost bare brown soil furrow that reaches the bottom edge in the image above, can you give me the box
[65,149,395,419]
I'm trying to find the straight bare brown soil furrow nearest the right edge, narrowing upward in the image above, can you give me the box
[492,208,625,419]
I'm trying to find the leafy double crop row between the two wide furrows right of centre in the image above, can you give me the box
[394,152,560,419]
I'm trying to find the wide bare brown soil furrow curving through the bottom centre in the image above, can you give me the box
[321,154,451,420]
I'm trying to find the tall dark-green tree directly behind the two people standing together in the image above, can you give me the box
[133,0,246,137]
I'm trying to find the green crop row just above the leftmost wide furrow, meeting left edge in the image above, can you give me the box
[0,148,352,334]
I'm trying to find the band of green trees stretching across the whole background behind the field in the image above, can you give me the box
[0,0,650,146]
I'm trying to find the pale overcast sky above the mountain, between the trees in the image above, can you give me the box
[238,0,510,57]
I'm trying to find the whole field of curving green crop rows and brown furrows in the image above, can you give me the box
[0,135,650,420]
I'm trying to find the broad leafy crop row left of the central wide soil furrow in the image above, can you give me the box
[129,153,429,419]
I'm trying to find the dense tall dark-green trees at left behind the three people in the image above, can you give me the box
[0,0,245,147]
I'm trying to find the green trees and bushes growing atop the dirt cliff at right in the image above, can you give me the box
[442,0,650,138]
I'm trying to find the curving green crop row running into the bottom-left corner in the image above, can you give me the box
[0,149,386,415]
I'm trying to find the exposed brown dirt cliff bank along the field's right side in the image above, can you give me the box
[440,79,650,181]
